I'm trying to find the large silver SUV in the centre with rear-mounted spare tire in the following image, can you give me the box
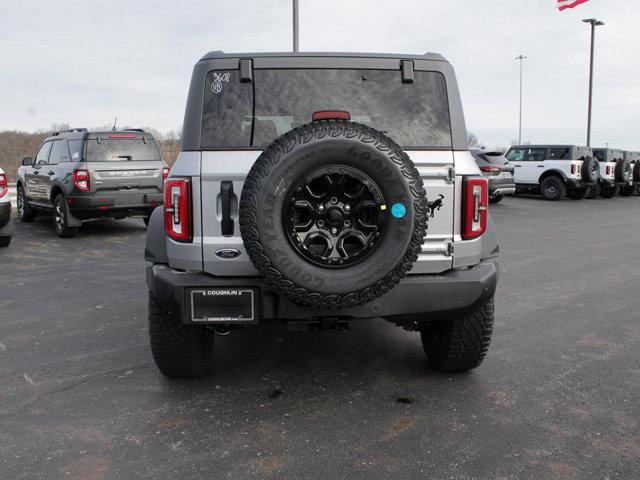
[145,52,498,377]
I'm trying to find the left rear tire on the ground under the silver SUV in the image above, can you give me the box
[149,292,214,378]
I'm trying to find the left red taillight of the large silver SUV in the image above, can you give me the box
[164,178,193,242]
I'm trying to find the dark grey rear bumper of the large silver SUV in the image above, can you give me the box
[147,262,498,324]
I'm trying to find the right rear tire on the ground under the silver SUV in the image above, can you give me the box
[420,298,494,372]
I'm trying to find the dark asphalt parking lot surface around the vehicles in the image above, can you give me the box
[0,197,640,479]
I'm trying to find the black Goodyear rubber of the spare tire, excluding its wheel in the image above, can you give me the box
[240,122,426,303]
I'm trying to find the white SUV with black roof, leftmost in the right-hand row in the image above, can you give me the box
[505,145,600,200]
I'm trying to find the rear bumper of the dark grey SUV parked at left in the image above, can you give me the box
[67,193,162,219]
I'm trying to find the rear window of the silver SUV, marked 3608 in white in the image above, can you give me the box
[202,69,452,148]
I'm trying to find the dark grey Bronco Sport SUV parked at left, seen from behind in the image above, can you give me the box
[17,128,169,237]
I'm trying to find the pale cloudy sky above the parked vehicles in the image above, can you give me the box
[0,0,640,150]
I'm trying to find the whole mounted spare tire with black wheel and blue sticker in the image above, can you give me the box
[240,120,428,307]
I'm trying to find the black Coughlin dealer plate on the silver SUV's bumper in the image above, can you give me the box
[190,288,257,323]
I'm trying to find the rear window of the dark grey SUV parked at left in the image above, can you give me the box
[85,138,160,162]
